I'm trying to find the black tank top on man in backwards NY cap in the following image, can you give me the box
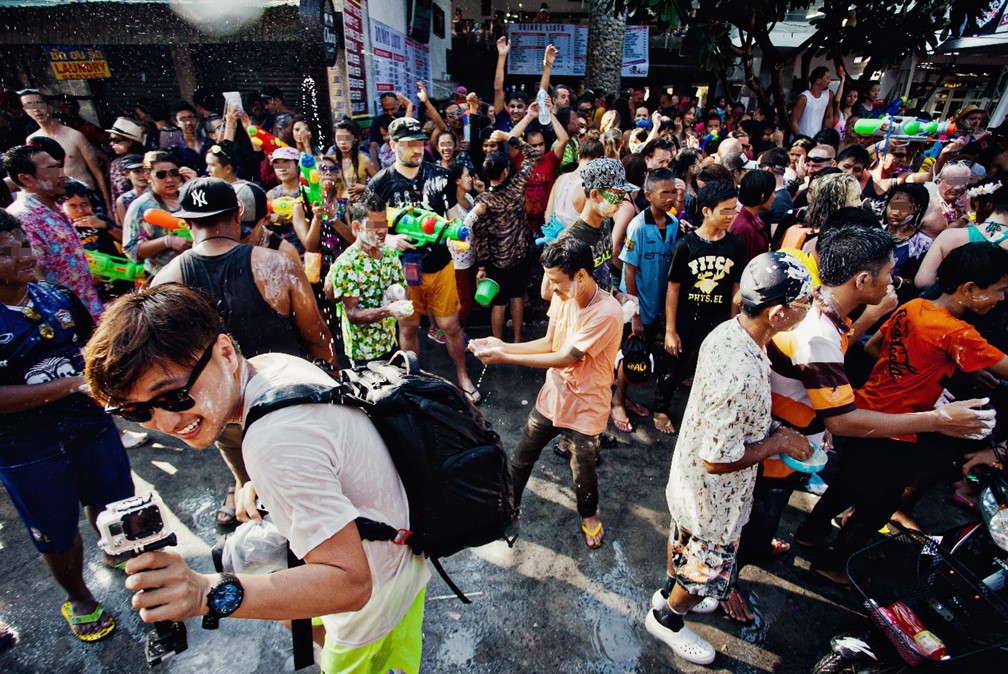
[179,244,304,358]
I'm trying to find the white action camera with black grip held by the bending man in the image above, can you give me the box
[95,494,188,667]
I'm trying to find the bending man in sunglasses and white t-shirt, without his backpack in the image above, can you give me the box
[86,282,429,672]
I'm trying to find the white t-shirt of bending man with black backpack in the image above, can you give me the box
[242,354,430,648]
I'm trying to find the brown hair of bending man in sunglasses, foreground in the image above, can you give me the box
[84,283,228,404]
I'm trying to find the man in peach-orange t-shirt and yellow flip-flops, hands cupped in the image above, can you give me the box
[469,237,623,549]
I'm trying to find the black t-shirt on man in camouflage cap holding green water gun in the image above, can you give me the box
[367,161,456,274]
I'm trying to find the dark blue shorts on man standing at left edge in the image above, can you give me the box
[0,417,133,553]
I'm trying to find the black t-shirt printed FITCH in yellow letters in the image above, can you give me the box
[668,232,747,336]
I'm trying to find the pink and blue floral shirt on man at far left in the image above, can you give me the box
[7,189,104,321]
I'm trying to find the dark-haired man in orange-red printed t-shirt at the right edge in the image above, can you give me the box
[795,243,1008,584]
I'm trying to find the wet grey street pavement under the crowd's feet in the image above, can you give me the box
[0,328,1004,674]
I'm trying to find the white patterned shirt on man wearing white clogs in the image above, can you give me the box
[665,318,770,545]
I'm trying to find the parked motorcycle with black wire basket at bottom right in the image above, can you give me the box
[811,466,1008,674]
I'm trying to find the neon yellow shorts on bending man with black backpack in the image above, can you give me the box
[322,587,427,674]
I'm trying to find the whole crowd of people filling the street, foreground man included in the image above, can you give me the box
[0,39,1008,672]
